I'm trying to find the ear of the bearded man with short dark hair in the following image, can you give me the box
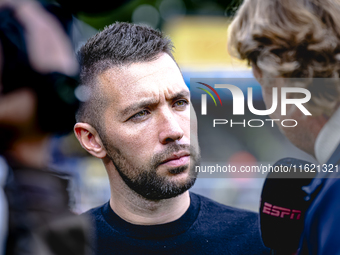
[74,122,106,158]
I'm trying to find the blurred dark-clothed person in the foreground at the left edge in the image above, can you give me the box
[0,1,89,255]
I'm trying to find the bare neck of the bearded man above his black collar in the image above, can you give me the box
[105,161,190,225]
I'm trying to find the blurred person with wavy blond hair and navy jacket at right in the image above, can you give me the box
[228,0,340,254]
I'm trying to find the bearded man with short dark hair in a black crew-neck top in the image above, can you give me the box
[74,23,268,255]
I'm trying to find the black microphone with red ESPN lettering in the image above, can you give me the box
[259,158,316,255]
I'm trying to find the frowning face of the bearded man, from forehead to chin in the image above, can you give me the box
[99,54,200,200]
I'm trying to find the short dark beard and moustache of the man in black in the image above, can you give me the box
[106,144,200,200]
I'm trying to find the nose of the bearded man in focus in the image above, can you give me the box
[159,109,184,144]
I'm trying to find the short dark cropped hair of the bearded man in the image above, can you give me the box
[76,22,173,133]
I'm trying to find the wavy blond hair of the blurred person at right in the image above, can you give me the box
[228,0,340,115]
